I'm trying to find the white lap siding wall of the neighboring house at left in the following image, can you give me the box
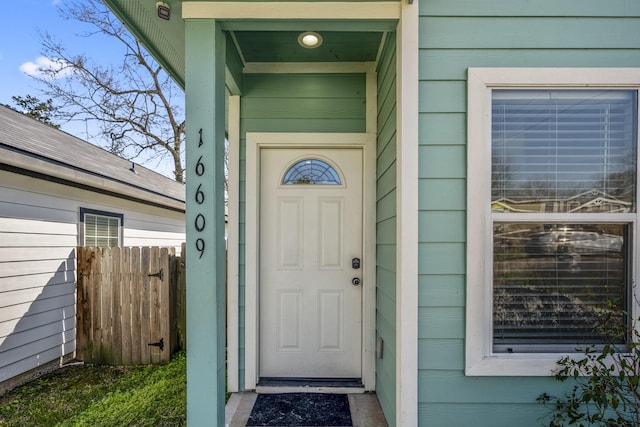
[0,171,184,388]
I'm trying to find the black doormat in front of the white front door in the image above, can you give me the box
[247,393,353,426]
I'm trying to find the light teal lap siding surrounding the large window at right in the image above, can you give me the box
[418,0,640,426]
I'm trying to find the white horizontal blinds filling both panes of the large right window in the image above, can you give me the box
[491,89,637,353]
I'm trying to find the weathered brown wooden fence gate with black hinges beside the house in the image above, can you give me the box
[76,245,185,365]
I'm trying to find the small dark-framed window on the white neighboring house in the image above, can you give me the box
[80,208,124,247]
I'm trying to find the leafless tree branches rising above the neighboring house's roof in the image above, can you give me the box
[35,0,185,182]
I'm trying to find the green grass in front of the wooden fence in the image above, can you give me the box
[0,353,187,427]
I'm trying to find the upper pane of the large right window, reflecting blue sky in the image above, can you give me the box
[491,89,638,213]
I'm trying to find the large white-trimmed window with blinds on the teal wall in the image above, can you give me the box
[467,70,640,373]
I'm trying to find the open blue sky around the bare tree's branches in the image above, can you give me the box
[0,0,178,176]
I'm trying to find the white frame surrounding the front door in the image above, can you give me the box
[244,132,376,391]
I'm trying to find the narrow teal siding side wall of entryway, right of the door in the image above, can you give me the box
[376,31,397,425]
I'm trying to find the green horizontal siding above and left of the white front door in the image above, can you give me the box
[238,74,366,389]
